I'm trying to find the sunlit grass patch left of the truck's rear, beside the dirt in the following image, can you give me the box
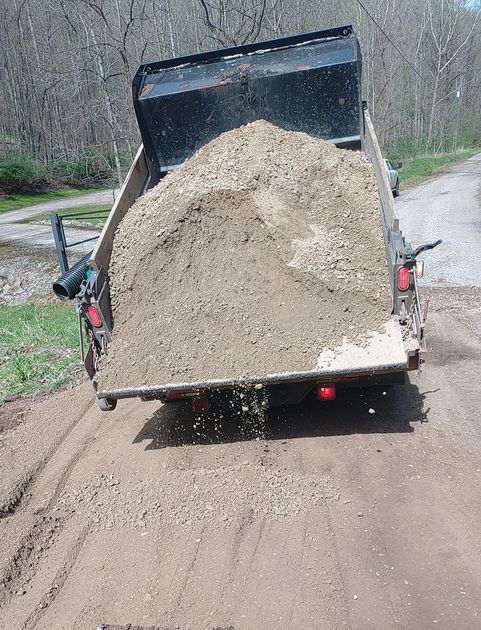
[0,303,81,401]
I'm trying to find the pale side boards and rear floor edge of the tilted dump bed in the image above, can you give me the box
[92,117,423,410]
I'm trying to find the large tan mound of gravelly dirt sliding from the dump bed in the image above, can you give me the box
[99,121,391,390]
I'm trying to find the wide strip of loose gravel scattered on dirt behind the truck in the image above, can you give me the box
[57,461,333,531]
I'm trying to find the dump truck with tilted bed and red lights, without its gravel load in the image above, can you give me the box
[52,26,438,411]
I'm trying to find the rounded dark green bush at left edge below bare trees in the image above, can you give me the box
[0,153,50,194]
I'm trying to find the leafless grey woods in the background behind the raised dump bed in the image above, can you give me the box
[0,0,481,181]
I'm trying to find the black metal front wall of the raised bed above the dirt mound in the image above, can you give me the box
[133,26,361,184]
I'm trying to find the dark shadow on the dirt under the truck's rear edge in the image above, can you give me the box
[134,384,429,450]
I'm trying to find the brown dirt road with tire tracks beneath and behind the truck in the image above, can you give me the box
[0,159,481,630]
